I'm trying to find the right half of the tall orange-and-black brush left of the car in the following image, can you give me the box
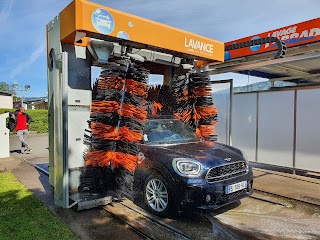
[112,60,149,196]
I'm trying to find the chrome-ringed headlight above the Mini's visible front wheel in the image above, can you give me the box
[172,158,202,177]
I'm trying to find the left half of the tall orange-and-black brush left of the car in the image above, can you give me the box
[79,62,127,192]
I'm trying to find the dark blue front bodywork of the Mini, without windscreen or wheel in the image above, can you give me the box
[134,120,253,215]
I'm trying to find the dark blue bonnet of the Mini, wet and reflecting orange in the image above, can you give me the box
[150,141,244,167]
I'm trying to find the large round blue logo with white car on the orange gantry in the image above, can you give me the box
[91,8,115,34]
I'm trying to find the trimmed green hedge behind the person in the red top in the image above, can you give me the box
[0,108,48,133]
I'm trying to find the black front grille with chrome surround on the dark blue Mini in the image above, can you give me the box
[206,162,247,183]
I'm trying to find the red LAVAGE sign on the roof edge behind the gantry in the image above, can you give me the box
[225,18,320,60]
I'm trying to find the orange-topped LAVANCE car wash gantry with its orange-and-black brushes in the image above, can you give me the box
[47,0,285,212]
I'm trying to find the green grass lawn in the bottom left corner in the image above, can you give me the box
[0,172,78,240]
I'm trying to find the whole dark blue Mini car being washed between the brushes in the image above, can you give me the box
[134,117,253,216]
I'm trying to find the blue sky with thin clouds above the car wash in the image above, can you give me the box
[0,0,320,97]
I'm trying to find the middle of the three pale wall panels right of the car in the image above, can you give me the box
[257,91,294,167]
